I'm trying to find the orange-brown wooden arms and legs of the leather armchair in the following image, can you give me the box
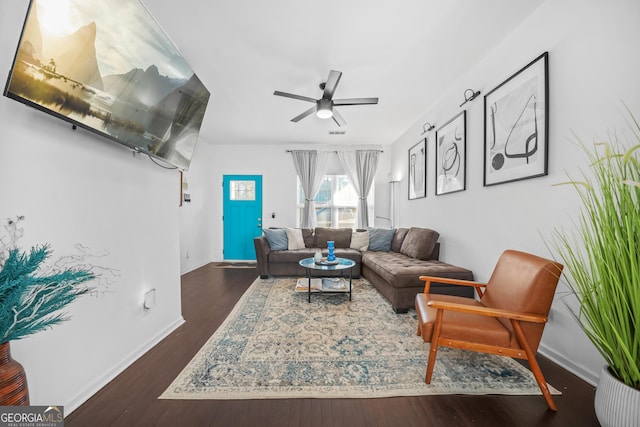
[416,276,558,411]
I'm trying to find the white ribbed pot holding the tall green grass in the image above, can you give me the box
[594,366,640,427]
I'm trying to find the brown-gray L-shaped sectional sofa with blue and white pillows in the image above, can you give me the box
[254,227,473,313]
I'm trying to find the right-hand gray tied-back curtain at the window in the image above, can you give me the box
[338,150,380,228]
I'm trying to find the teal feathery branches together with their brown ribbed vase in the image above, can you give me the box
[0,217,94,406]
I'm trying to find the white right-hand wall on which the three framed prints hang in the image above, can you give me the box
[384,0,640,382]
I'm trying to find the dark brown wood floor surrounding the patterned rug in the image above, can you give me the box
[65,265,599,427]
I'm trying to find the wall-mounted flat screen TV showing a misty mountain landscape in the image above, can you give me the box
[4,0,209,169]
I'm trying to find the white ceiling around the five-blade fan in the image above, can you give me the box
[143,0,544,145]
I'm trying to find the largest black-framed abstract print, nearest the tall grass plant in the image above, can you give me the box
[484,52,549,186]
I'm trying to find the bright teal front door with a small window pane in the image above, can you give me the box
[222,175,262,261]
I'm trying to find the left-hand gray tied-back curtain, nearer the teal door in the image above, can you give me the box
[291,150,329,228]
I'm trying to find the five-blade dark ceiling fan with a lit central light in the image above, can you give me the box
[273,70,378,126]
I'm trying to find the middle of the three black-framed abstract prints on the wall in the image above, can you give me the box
[436,111,467,196]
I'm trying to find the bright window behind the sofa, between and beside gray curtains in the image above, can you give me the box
[297,175,373,228]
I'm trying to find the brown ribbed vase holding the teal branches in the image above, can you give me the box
[0,342,29,406]
